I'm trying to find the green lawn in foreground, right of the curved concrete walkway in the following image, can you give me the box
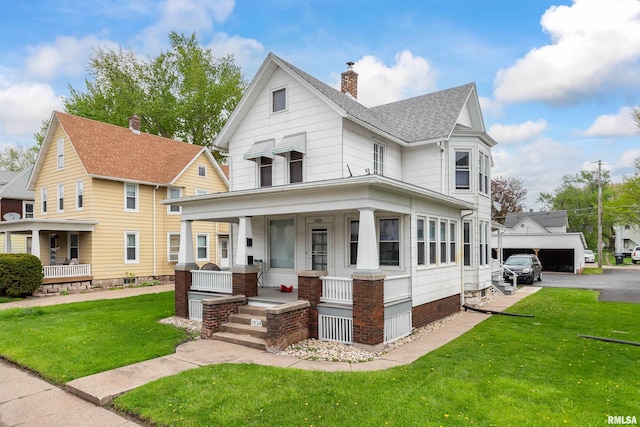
[114,289,640,426]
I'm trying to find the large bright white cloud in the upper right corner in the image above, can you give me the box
[494,0,640,103]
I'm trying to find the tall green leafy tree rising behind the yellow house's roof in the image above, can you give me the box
[64,32,247,158]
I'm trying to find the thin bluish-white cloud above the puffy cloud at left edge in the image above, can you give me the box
[25,36,117,81]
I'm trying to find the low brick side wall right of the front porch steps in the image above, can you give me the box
[265,301,309,353]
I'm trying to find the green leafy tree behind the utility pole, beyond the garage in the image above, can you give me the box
[538,170,617,248]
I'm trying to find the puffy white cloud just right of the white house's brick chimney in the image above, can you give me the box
[348,50,436,107]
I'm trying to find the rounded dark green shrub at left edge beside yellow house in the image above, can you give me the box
[0,254,43,298]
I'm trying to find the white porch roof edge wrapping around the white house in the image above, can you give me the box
[168,175,473,222]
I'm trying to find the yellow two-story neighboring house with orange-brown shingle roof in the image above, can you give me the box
[0,111,230,292]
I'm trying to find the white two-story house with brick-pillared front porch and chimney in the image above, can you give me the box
[171,54,496,352]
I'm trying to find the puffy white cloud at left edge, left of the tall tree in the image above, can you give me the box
[0,83,62,138]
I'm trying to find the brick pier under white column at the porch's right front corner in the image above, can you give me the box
[352,274,385,347]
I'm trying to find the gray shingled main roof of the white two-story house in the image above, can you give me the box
[271,54,475,142]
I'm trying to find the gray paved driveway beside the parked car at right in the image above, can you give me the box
[536,265,640,303]
